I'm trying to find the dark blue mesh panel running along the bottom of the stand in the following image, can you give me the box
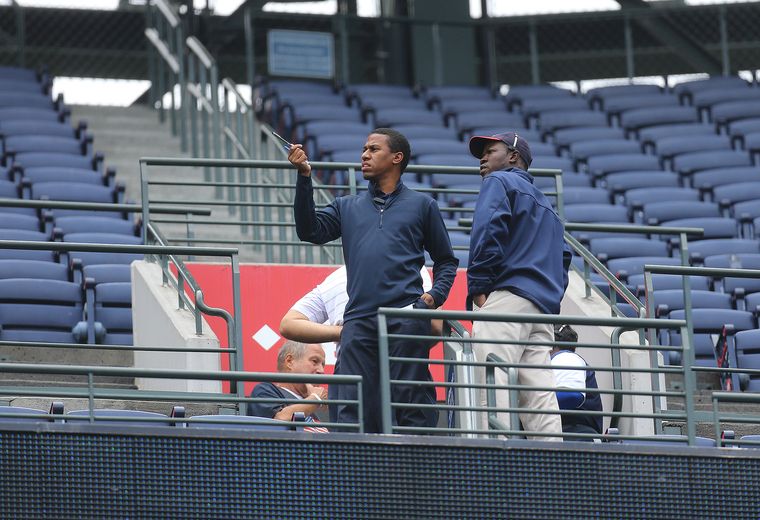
[0,426,760,519]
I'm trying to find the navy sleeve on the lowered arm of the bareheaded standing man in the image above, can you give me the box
[425,200,459,307]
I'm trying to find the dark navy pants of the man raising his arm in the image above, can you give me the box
[331,317,438,433]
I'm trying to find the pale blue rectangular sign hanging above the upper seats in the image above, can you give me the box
[267,30,335,79]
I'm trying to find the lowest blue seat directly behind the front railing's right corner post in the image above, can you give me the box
[667,309,757,367]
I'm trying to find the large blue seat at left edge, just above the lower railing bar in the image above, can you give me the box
[0,278,84,343]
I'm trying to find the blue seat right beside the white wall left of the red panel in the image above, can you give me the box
[87,282,133,345]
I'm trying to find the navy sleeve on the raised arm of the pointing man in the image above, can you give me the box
[293,175,340,244]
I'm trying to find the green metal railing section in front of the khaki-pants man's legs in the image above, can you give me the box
[378,308,696,444]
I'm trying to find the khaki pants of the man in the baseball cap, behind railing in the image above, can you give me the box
[472,291,562,442]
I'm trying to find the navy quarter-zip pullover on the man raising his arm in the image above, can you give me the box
[293,175,459,322]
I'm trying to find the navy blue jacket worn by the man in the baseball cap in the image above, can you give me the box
[467,168,572,314]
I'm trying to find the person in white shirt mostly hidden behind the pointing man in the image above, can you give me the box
[280,266,442,422]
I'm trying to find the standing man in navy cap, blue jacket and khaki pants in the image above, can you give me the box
[467,132,572,441]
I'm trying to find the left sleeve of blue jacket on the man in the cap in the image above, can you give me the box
[467,176,512,296]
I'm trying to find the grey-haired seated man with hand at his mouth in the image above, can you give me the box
[248,341,327,433]
